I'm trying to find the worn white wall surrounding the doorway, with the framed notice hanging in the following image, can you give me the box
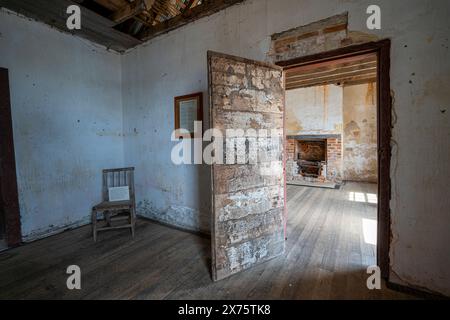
[122,0,450,295]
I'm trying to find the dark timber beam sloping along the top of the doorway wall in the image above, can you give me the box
[138,0,244,41]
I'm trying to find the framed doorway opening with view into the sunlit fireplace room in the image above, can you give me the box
[277,40,391,279]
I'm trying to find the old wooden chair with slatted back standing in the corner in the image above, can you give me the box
[92,168,136,241]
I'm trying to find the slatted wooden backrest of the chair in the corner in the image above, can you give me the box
[102,167,135,203]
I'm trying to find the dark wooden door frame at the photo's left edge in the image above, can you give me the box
[0,68,22,247]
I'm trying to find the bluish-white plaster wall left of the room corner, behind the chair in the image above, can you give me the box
[0,10,123,241]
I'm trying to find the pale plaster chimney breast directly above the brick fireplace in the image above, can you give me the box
[285,85,343,136]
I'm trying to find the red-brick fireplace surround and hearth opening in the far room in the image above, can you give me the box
[286,135,342,183]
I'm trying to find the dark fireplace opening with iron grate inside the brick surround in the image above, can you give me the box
[297,140,327,178]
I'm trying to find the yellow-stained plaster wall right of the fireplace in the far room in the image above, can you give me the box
[343,83,378,183]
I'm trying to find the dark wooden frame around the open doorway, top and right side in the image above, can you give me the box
[276,39,392,279]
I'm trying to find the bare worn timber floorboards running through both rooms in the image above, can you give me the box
[0,183,414,299]
